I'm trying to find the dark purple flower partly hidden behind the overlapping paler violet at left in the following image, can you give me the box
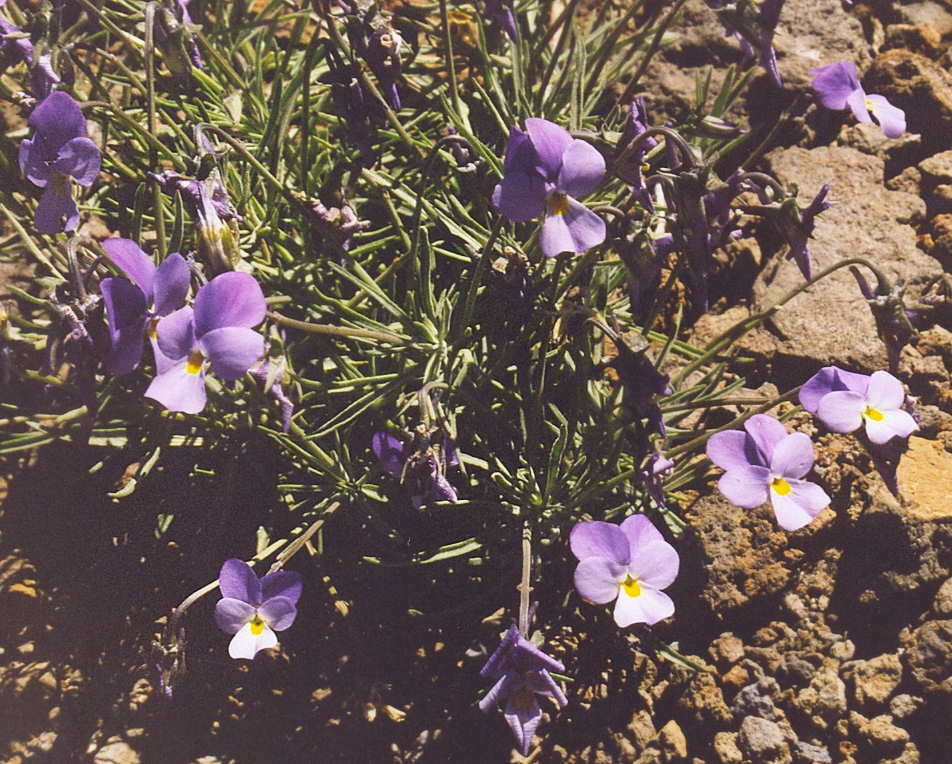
[99,238,190,374]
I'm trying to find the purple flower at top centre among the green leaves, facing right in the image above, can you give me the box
[492,117,605,257]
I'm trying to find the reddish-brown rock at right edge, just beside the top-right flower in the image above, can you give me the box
[863,50,952,148]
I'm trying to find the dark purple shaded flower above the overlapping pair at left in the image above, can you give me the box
[19,91,100,233]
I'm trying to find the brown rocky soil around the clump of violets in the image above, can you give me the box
[0,0,952,764]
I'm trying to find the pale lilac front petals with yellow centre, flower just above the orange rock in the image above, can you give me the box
[816,371,919,445]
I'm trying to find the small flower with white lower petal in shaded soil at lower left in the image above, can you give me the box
[215,558,304,660]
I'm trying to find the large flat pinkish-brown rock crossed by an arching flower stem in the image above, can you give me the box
[752,146,939,376]
